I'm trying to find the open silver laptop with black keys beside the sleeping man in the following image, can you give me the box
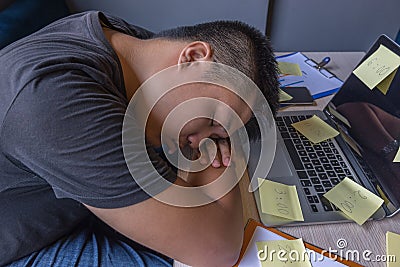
[248,35,400,226]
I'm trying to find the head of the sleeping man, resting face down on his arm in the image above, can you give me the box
[141,21,279,156]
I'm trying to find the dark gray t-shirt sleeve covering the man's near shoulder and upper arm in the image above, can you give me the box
[1,70,176,208]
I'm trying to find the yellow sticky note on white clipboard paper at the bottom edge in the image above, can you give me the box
[256,238,312,267]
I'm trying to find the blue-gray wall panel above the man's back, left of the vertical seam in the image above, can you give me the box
[67,0,268,33]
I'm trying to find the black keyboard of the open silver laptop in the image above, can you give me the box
[276,115,354,212]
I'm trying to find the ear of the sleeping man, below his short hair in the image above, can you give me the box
[178,41,213,64]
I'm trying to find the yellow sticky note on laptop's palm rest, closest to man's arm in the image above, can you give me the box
[258,178,304,221]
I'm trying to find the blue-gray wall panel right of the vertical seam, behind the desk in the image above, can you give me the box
[269,0,400,51]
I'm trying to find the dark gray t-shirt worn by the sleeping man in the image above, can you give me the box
[0,12,176,265]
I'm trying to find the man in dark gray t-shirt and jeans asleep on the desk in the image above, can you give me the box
[0,11,278,266]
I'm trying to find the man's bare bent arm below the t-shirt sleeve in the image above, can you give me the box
[87,166,244,267]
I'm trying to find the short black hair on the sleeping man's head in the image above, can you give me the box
[154,21,279,114]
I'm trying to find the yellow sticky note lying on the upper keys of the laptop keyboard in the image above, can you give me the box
[292,115,339,144]
